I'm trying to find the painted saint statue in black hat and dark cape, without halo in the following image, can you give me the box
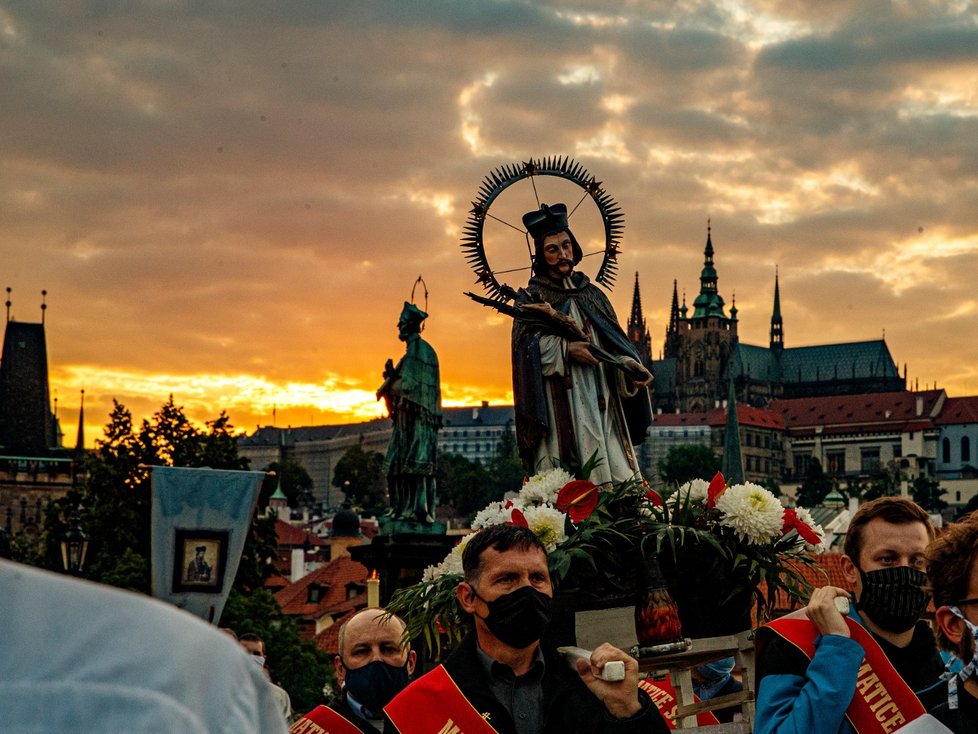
[513,204,652,484]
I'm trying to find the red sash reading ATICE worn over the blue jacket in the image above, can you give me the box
[767,617,925,734]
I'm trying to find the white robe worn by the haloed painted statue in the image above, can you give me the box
[534,300,641,484]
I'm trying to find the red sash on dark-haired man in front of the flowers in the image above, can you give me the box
[384,665,497,734]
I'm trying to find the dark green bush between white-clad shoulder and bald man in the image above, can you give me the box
[221,589,336,712]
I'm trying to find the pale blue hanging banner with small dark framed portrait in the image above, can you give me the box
[151,466,265,624]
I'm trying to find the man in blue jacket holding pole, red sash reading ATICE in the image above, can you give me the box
[754,497,946,734]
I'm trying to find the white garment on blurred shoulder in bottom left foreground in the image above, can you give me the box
[0,560,288,734]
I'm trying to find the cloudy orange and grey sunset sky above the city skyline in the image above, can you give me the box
[0,0,978,445]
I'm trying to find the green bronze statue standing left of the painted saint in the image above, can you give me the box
[377,302,441,525]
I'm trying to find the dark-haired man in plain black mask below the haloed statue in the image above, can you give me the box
[384,525,669,734]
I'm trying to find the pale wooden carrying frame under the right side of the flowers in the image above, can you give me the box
[638,630,756,734]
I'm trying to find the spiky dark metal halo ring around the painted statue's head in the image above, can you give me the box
[461,156,625,301]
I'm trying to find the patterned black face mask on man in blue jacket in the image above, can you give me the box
[856,566,930,632]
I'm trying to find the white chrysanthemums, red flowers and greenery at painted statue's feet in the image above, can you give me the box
[388,468,824,656]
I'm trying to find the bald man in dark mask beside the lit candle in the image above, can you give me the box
[291,609,417,734]
